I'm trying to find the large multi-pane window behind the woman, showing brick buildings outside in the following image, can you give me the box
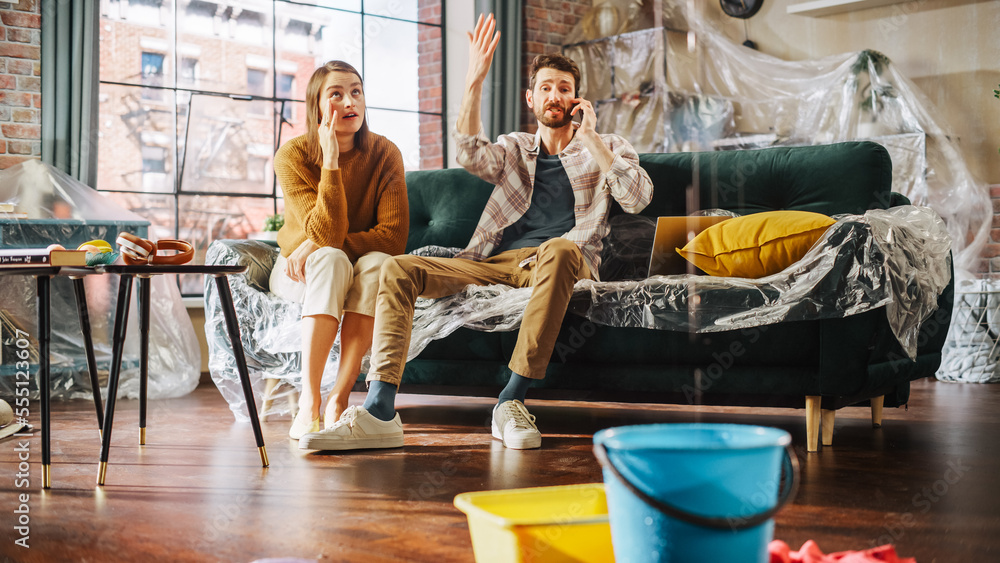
[98,0,447,295]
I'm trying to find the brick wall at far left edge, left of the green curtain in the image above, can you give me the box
[0,0,42,170]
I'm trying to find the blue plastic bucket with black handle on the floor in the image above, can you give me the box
[594,424,798,563]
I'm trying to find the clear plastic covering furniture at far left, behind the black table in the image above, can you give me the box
[0,160,201,399]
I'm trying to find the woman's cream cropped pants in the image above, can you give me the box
[270,246,389,320]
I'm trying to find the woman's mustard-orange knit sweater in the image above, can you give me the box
[274,133,410,262]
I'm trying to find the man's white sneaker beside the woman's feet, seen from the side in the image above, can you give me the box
[299,405,403,451]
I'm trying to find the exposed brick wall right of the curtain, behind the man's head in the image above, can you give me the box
[519,0,593,132]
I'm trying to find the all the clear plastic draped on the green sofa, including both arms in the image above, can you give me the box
[205,205,951,420]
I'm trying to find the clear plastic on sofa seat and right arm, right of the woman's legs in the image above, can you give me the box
[398,205,951,359]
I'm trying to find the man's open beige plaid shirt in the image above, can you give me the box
[453,124,653,280]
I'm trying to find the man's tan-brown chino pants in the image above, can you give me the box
[367,238,591,385]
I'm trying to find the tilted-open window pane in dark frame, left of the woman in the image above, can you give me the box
[180,94,274,194]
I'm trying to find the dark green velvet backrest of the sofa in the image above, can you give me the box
[406,141,895,252]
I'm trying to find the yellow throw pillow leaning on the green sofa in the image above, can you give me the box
[677,211,836,278]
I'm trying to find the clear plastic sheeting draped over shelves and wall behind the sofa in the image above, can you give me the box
[563,0,992,273]
